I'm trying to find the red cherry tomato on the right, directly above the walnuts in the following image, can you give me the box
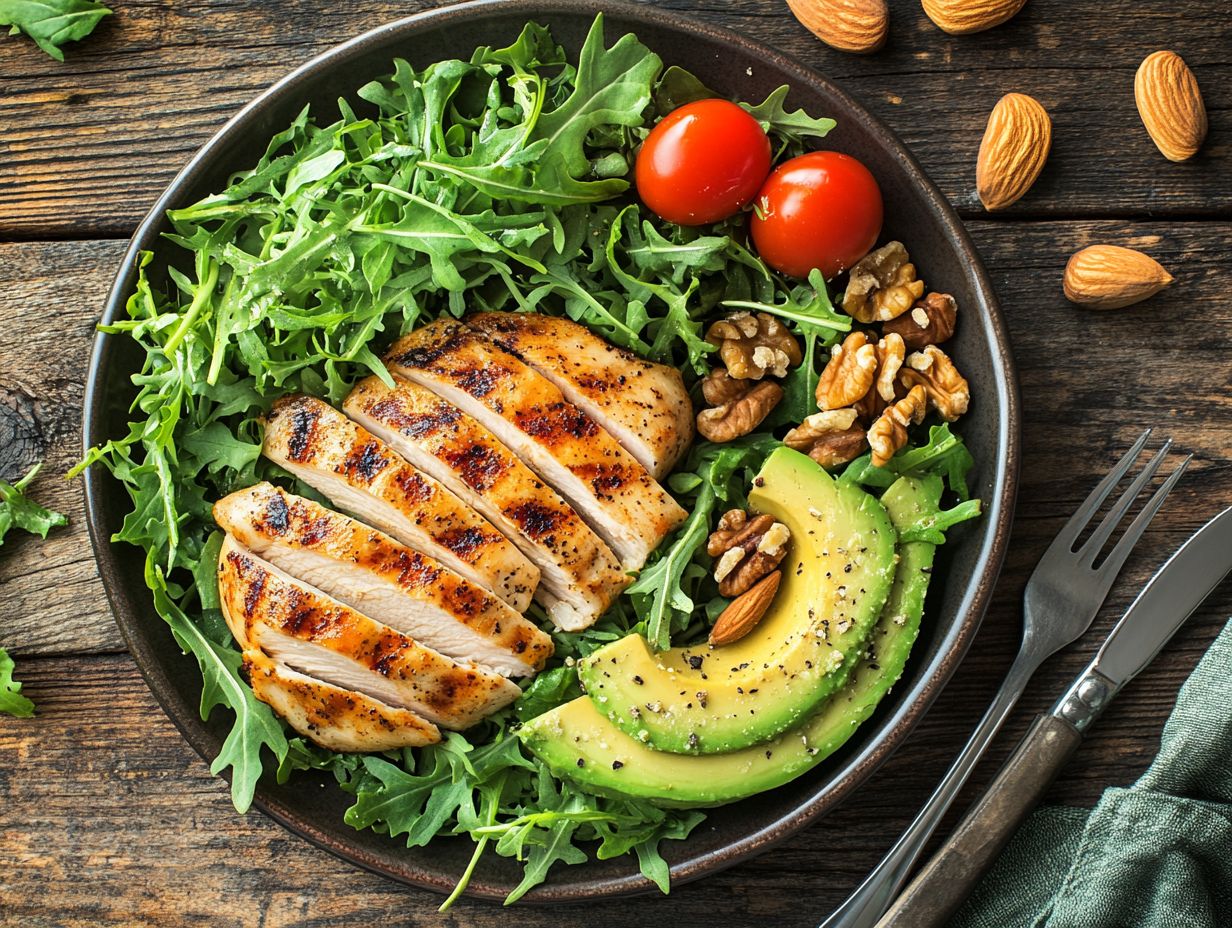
[752,152,882,280]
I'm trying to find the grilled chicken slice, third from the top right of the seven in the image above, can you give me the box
[342,377,630,631]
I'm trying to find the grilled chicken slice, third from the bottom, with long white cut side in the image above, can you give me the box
[214,483,552,677]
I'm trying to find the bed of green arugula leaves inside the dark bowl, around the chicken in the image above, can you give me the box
[79,16,980,905]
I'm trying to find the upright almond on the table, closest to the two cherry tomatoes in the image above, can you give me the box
[976,94,1052,210]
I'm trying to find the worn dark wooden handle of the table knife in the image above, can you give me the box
[877,715,1082,928]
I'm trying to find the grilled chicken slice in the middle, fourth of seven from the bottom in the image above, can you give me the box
[262,396,538,613]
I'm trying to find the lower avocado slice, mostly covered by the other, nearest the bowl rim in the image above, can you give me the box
[519,477,941,806]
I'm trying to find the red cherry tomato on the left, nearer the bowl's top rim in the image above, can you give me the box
[634,100,770,226]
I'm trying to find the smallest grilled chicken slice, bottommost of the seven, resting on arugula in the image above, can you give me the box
[244,648,441,751]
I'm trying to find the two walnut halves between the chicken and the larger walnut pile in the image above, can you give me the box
[697,313,803,441]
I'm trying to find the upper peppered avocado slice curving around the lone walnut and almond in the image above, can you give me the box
[578,447,897,754]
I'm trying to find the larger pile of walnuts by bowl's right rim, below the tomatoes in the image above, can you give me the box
[784,242,971,467]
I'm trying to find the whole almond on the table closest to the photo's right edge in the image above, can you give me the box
[1133,52,1206,161]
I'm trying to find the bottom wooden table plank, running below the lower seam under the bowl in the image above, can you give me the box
[0,640,1214,928]
